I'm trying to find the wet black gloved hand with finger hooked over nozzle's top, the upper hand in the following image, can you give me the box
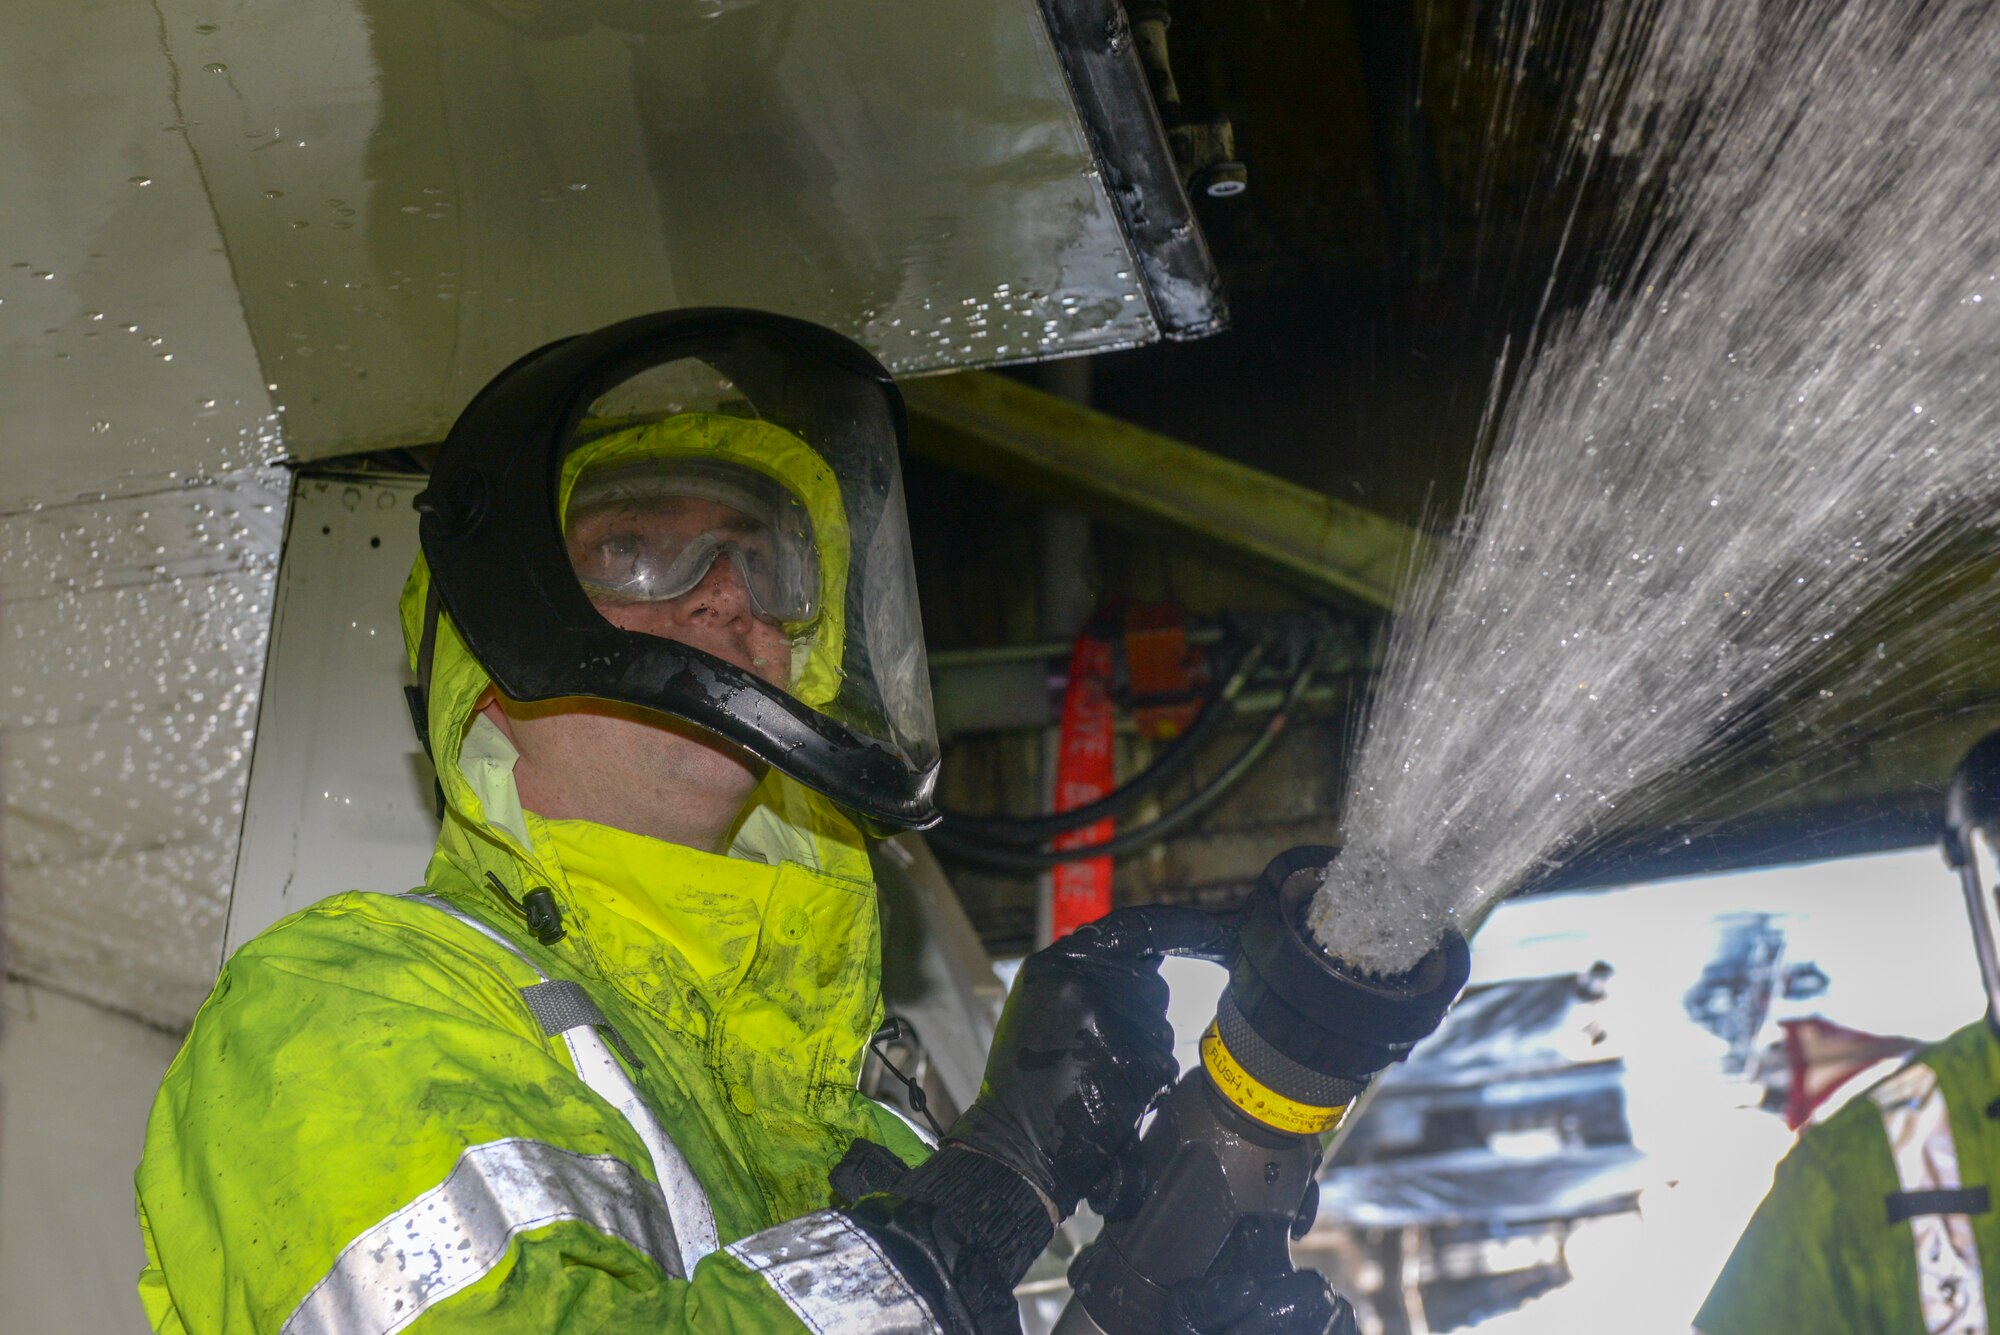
[944,903,1234,1217]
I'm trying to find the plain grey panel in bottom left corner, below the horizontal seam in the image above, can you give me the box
[0,981,180,1335]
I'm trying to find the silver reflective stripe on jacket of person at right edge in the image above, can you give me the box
[1868,1061,1986,1335]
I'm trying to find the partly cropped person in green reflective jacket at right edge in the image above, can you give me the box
[1694,731,2000,1335]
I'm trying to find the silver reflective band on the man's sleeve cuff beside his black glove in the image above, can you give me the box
[726,1209,944,1335]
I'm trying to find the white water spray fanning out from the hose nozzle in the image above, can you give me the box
[1314,0,2000,987]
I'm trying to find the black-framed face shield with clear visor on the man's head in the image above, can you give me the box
[416,308,938,829]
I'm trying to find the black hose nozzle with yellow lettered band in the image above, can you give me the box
[1056,847,1470,1335]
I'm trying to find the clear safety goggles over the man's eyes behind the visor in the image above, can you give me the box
[564,458,820,636]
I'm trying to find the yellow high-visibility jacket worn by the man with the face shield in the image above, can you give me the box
[138,535,936,1335]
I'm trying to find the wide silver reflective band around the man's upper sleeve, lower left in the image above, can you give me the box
[282,1139,674,1335]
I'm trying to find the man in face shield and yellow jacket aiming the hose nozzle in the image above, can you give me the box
[138,310,1352,1335]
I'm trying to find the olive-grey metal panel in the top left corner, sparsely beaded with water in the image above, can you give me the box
[0,0,278,514]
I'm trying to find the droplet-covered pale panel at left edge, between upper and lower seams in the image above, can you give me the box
[0,474,284,1025]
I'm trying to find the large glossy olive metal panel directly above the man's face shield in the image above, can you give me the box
[160,0,1156,458]
